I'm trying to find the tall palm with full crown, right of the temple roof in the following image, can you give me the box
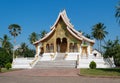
[92,23,108,52]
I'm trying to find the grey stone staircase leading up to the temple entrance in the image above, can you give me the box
[34,53,76,69]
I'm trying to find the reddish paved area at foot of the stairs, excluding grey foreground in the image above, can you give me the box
[0,69,79,76]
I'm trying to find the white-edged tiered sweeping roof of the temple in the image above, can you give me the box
[33,10,95,44]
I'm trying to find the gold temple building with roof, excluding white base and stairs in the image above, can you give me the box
[34,10,95,56]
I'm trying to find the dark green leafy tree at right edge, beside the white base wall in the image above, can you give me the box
[103,39,120,67]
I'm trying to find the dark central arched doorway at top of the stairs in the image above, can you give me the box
[56,38,67,53]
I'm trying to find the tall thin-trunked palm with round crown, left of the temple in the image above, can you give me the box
[8,24,21,59]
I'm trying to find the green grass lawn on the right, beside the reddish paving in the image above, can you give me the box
[80,68,120,77]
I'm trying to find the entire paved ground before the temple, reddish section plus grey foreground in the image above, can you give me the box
[0,69,120,83]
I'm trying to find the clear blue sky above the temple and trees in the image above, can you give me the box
[0,0,120,48]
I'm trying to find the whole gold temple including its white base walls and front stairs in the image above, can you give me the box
[12,10,115,69]
